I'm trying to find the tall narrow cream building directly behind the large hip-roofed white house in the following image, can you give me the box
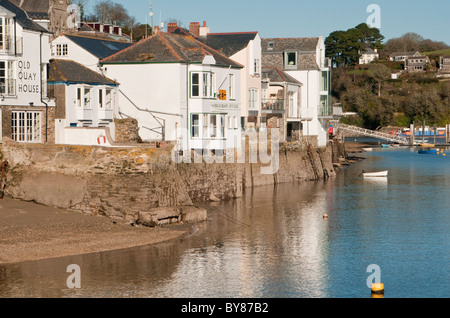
[199,32,261,130]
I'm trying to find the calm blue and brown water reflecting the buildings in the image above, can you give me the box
[0,144,450,298]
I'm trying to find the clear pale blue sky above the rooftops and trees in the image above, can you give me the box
[86,0,450,45]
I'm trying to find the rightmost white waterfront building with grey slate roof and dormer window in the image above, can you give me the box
[262,37,333,147]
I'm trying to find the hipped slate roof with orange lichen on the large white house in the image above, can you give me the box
[101,32,243,68]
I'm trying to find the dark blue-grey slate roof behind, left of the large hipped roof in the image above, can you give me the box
[64,34,133,60]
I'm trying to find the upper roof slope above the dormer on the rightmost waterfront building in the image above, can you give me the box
[261,37,319,52]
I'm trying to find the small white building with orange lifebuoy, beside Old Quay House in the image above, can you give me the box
[48,60,118,146]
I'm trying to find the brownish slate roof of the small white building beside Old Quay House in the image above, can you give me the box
[48,59,118,85]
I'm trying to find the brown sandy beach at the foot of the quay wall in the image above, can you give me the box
[0,198,190,264]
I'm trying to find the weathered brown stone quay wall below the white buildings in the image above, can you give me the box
[1,138,335,226]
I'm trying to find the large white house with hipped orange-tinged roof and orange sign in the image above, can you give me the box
[101,30,242,150]
